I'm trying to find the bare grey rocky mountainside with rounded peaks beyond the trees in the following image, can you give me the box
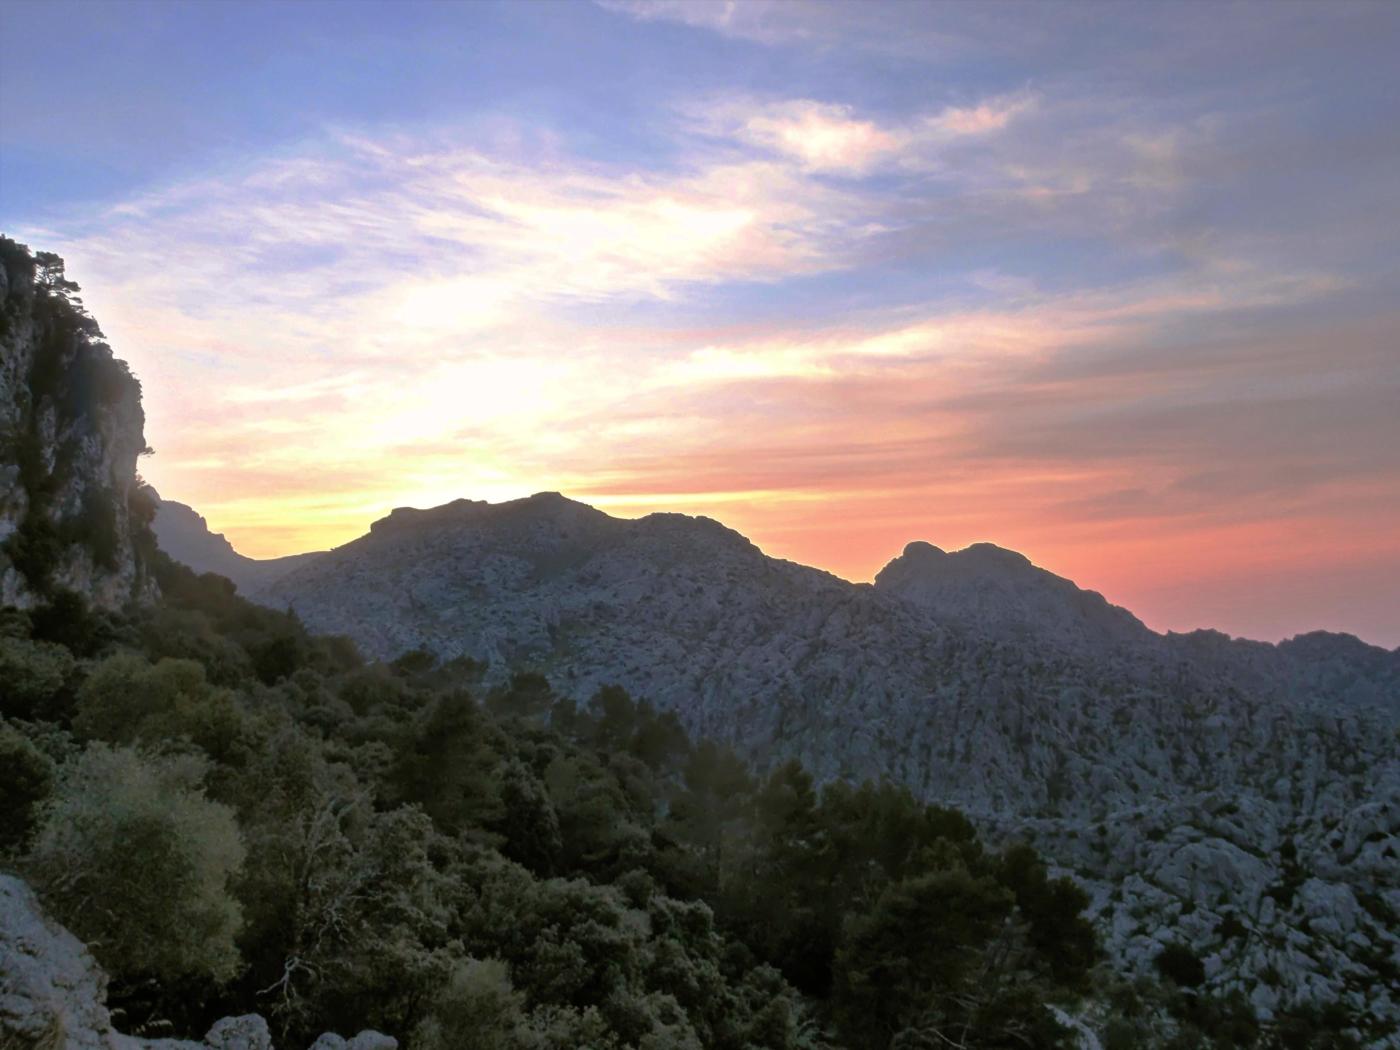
[246,494,1400,1036]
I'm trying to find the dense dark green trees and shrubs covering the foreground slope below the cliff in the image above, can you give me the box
[0,557,1095,1047]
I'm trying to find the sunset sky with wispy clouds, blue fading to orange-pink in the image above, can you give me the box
[0,0,1400,647]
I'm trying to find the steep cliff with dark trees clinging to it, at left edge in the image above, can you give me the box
[0,238,148,609]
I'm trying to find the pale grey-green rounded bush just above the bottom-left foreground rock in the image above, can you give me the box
[22,743,244,981]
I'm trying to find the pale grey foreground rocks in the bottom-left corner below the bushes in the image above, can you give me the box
[0,875,399,1050]
